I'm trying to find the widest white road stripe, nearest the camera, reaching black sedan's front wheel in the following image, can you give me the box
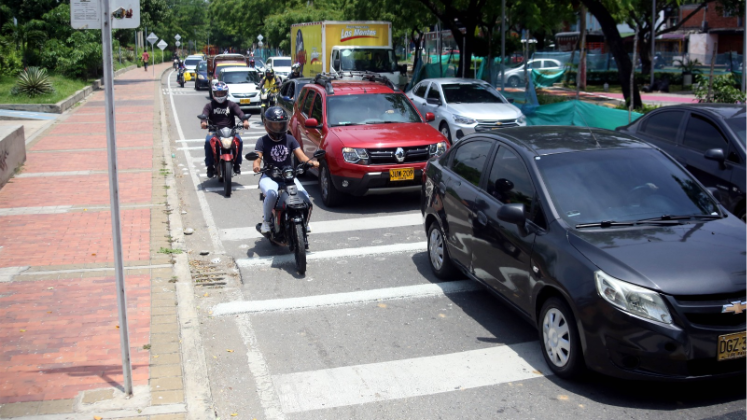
[272,341,551,414]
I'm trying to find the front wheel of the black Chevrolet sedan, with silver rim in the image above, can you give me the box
[539,297,586,379]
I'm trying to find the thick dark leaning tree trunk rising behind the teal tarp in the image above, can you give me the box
[581,0,641,108]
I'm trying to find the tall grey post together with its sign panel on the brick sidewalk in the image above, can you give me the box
[70,0,140,396]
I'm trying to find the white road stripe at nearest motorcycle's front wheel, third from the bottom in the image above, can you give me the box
[236,241,427,267]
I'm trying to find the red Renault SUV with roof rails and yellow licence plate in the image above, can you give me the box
[290,75,448,207]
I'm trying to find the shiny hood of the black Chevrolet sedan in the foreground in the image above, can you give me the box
[568,216,747,295]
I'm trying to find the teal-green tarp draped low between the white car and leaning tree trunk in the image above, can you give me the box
[526,100,643,130]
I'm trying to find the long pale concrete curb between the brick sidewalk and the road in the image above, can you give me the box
[159,69,215,420]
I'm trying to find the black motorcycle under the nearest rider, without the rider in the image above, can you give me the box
[246,150,326,274]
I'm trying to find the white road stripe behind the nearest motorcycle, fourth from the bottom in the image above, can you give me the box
[220,212,423,241]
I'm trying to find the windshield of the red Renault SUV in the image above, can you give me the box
[327,93,421,127]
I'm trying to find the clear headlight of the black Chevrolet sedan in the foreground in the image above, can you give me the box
[594,270,672,324]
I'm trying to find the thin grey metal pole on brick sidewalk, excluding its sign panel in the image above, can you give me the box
[101,0,132,396]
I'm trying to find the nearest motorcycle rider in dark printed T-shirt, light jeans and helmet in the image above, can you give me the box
[253,106,319,233]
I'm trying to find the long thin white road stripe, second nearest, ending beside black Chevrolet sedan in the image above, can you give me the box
[213,280,482,316]
